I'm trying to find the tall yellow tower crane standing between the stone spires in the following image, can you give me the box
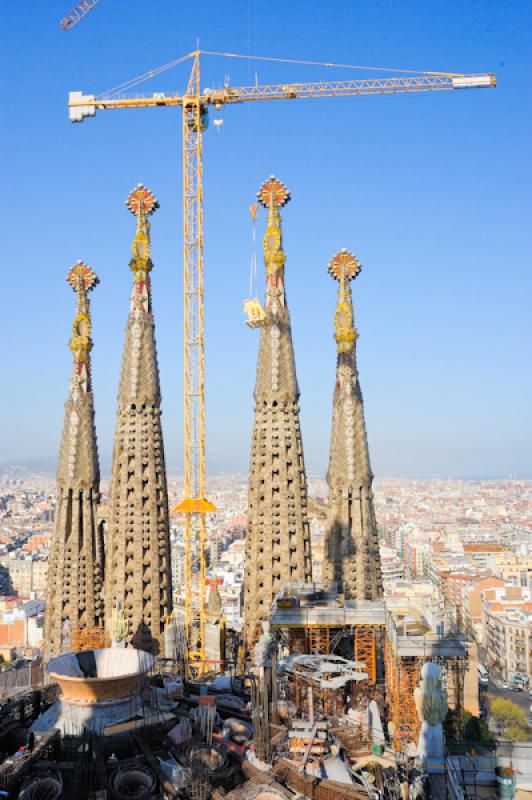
[68,50,496,671]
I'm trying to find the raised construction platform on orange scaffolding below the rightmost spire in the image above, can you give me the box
[270,584,469,749]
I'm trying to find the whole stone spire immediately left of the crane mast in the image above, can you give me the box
[105,184,172,652]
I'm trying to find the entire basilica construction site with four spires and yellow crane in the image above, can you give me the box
[0,2,512,800]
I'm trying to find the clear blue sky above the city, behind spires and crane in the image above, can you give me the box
[0,0,532,477]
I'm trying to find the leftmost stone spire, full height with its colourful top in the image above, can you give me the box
[44,261,104,659]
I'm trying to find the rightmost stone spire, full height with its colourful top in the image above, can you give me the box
[324,250,382,600]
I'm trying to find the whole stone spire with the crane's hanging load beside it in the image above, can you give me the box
[244,177,311,643]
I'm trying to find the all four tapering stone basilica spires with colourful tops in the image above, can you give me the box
[45,178,382,656]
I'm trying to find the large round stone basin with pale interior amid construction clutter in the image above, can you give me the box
[46,647,155,705]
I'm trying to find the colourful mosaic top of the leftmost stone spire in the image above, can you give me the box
[66,261,100,397]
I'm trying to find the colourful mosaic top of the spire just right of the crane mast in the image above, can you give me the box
[257,175,290,313]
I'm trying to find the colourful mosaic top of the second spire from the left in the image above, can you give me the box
[125,183,159,314]
